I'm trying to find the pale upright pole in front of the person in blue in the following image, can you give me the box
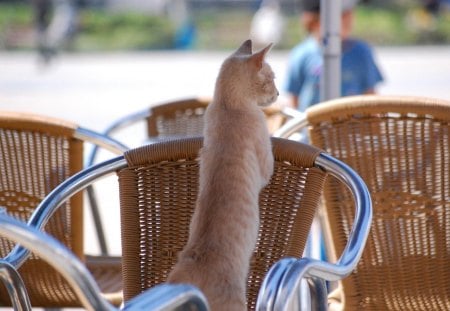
[320,0,342,101]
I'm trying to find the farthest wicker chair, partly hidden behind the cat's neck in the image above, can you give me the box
[88,97,298,254]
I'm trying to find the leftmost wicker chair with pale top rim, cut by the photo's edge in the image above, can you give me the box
[0,111,125,308]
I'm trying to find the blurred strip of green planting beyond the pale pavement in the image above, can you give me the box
[0,0,450,52]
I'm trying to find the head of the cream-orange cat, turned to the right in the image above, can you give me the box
[218,40,278,106]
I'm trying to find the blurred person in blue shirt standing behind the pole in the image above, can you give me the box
[285,0,383,111]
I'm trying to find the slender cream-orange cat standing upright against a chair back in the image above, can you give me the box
[168,40,278,311]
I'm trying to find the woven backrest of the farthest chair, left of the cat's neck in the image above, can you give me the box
[147,98,209,137]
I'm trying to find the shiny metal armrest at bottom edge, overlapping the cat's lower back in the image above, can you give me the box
[123,284,209,311]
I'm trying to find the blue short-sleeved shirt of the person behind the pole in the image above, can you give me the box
[286,36,383,111]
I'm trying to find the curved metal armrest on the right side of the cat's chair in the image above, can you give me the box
[257,153,372,311]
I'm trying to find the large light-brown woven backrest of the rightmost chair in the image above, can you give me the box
[307,96,450,310]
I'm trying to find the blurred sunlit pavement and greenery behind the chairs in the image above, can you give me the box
[0,0,450,253]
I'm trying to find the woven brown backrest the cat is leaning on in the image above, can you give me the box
[119,138,325,309]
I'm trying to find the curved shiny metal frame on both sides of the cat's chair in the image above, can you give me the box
[10,138,372,310]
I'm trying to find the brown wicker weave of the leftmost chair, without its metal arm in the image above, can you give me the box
[0,115,83,306]
